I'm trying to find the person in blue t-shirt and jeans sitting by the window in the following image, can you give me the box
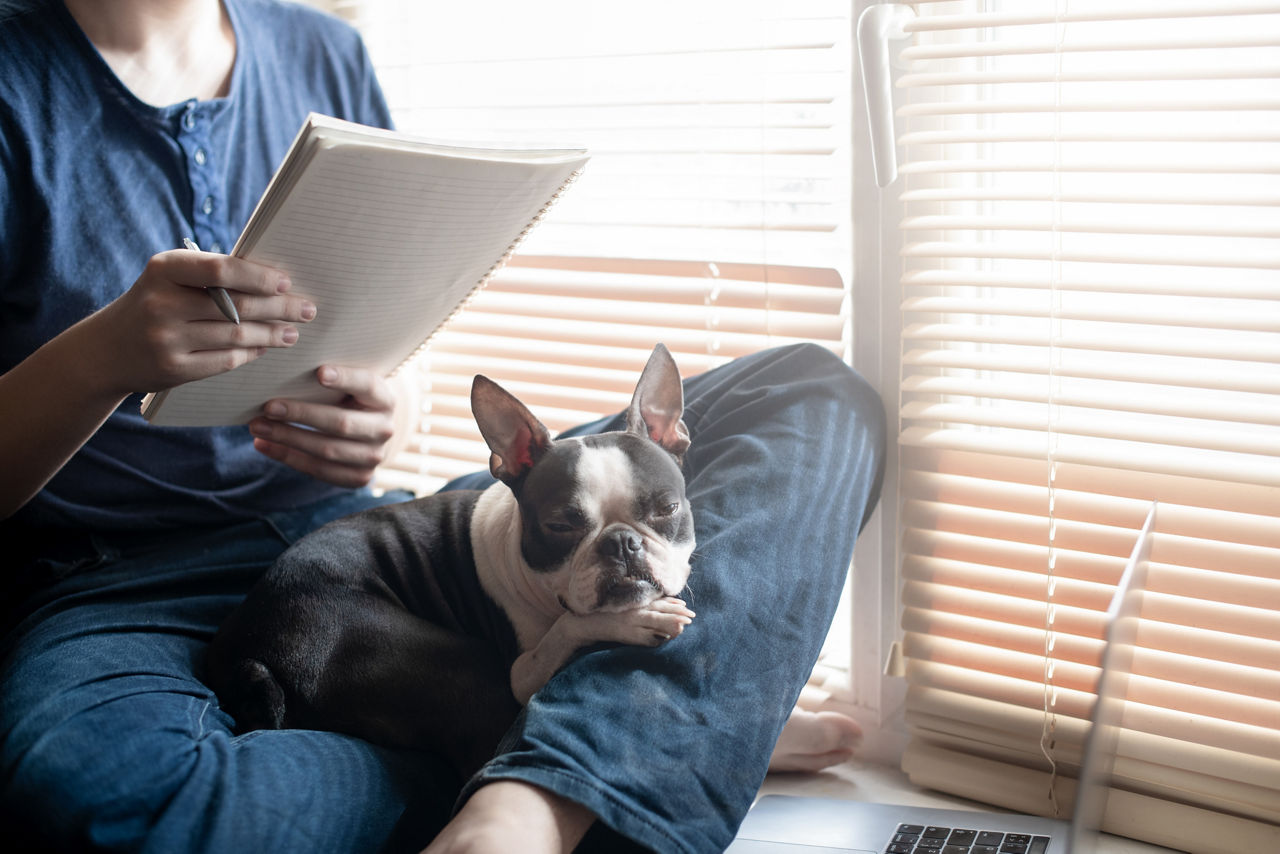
[0,0,884,851]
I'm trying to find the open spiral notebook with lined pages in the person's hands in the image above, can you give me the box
[142,114,588,426]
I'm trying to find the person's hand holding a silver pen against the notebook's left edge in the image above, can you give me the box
[84,250,316,396]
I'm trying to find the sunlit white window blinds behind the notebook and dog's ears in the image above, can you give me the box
[338,0,852,492]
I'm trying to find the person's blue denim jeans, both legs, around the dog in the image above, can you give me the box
[0,346,884,853]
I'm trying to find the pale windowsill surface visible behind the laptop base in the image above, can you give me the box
[760,759,1172,854]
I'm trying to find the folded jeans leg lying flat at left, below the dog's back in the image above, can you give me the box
[0,493,440,851]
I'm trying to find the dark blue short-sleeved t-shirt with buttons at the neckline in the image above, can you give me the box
[0,0,390,533]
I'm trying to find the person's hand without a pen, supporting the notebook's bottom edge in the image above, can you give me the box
[248,365,396,487]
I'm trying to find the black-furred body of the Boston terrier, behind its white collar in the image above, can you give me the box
[207,492,518,775]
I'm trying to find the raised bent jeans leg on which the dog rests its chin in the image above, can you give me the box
[467,346,884,853]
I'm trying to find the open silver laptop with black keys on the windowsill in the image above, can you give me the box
[727,503,1157,854]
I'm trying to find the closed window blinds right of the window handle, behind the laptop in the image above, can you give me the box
[895,0,1280,851]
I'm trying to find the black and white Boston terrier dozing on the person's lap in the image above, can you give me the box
[207,344,694,773]
